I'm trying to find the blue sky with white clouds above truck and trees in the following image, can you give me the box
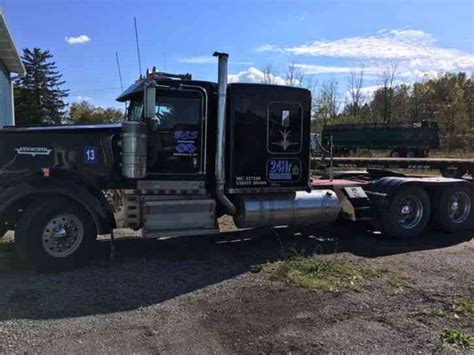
[0,0,474,107]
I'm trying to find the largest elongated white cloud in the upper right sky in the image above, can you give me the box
[257,29,474,76]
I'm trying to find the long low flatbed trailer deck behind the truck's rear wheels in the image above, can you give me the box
[311,157,474,178]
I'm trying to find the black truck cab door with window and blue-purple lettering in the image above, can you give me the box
[148,90,204,179]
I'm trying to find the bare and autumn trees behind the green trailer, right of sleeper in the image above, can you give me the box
[262,63,474,150]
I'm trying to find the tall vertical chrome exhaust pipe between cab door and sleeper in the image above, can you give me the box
[213,52,236,216]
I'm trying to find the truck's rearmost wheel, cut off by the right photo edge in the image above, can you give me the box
[433,184,474,233]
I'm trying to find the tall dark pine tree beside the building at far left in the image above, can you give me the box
[15,48,69,125]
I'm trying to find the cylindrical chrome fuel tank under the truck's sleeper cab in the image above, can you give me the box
[234,190,341,228]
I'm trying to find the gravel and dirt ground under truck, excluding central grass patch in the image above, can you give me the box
[0,221,474,354]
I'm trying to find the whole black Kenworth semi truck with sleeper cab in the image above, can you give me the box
[0,53,474,271]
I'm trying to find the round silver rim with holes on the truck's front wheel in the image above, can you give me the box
[42,214,84,258]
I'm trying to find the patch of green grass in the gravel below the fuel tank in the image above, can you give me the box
[265,256,383,292]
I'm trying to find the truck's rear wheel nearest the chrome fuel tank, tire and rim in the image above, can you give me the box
[378,186,431,239]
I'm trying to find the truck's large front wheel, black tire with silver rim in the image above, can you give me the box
[15,197,97,272]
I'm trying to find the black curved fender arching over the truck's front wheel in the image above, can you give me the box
[0,174,116,234]
